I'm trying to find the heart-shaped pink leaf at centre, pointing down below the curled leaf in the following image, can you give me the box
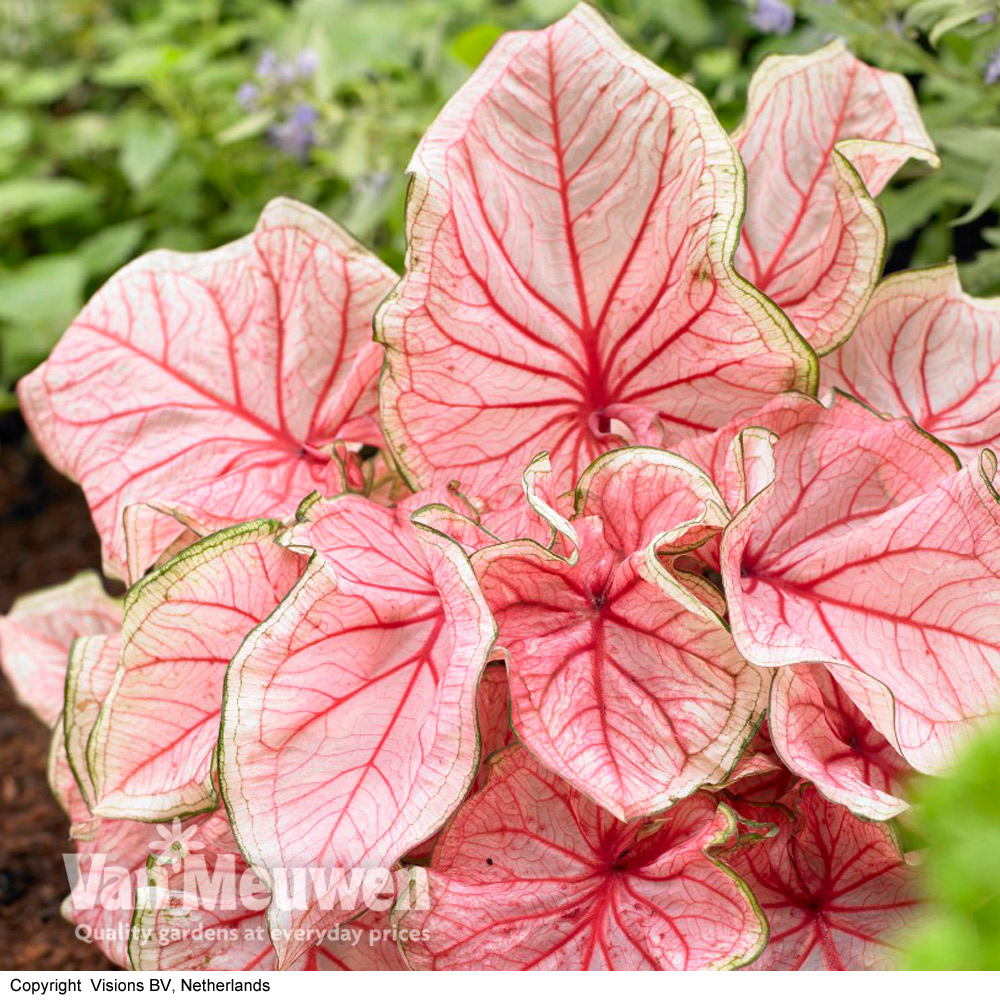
[474,518,766,819]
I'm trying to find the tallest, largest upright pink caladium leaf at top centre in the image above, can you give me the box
[376,5,816,496]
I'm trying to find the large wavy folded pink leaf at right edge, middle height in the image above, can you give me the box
[721,397,1000,772]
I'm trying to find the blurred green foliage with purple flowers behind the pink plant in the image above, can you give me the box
[0,0,1000,408]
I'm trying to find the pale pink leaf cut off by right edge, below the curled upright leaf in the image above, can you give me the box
[823,264,1000,462]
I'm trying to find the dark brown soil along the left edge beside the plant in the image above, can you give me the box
[0,416,114,971]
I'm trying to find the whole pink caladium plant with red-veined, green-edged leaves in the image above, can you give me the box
[0,5,1000,969]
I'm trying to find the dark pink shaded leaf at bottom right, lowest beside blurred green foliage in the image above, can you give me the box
[726,786,919,970]
